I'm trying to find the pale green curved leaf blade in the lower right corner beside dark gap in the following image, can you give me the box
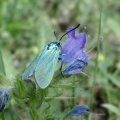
[102,103,120,116]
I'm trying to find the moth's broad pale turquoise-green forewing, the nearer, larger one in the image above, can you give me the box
[35,49,60,89]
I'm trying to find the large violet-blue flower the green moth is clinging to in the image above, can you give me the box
[61,28,88,75]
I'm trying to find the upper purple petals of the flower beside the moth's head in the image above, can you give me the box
[61,29,87,62]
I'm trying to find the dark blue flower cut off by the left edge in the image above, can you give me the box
[0,89,9,112]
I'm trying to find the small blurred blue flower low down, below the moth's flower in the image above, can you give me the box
[67,105,89,116]
